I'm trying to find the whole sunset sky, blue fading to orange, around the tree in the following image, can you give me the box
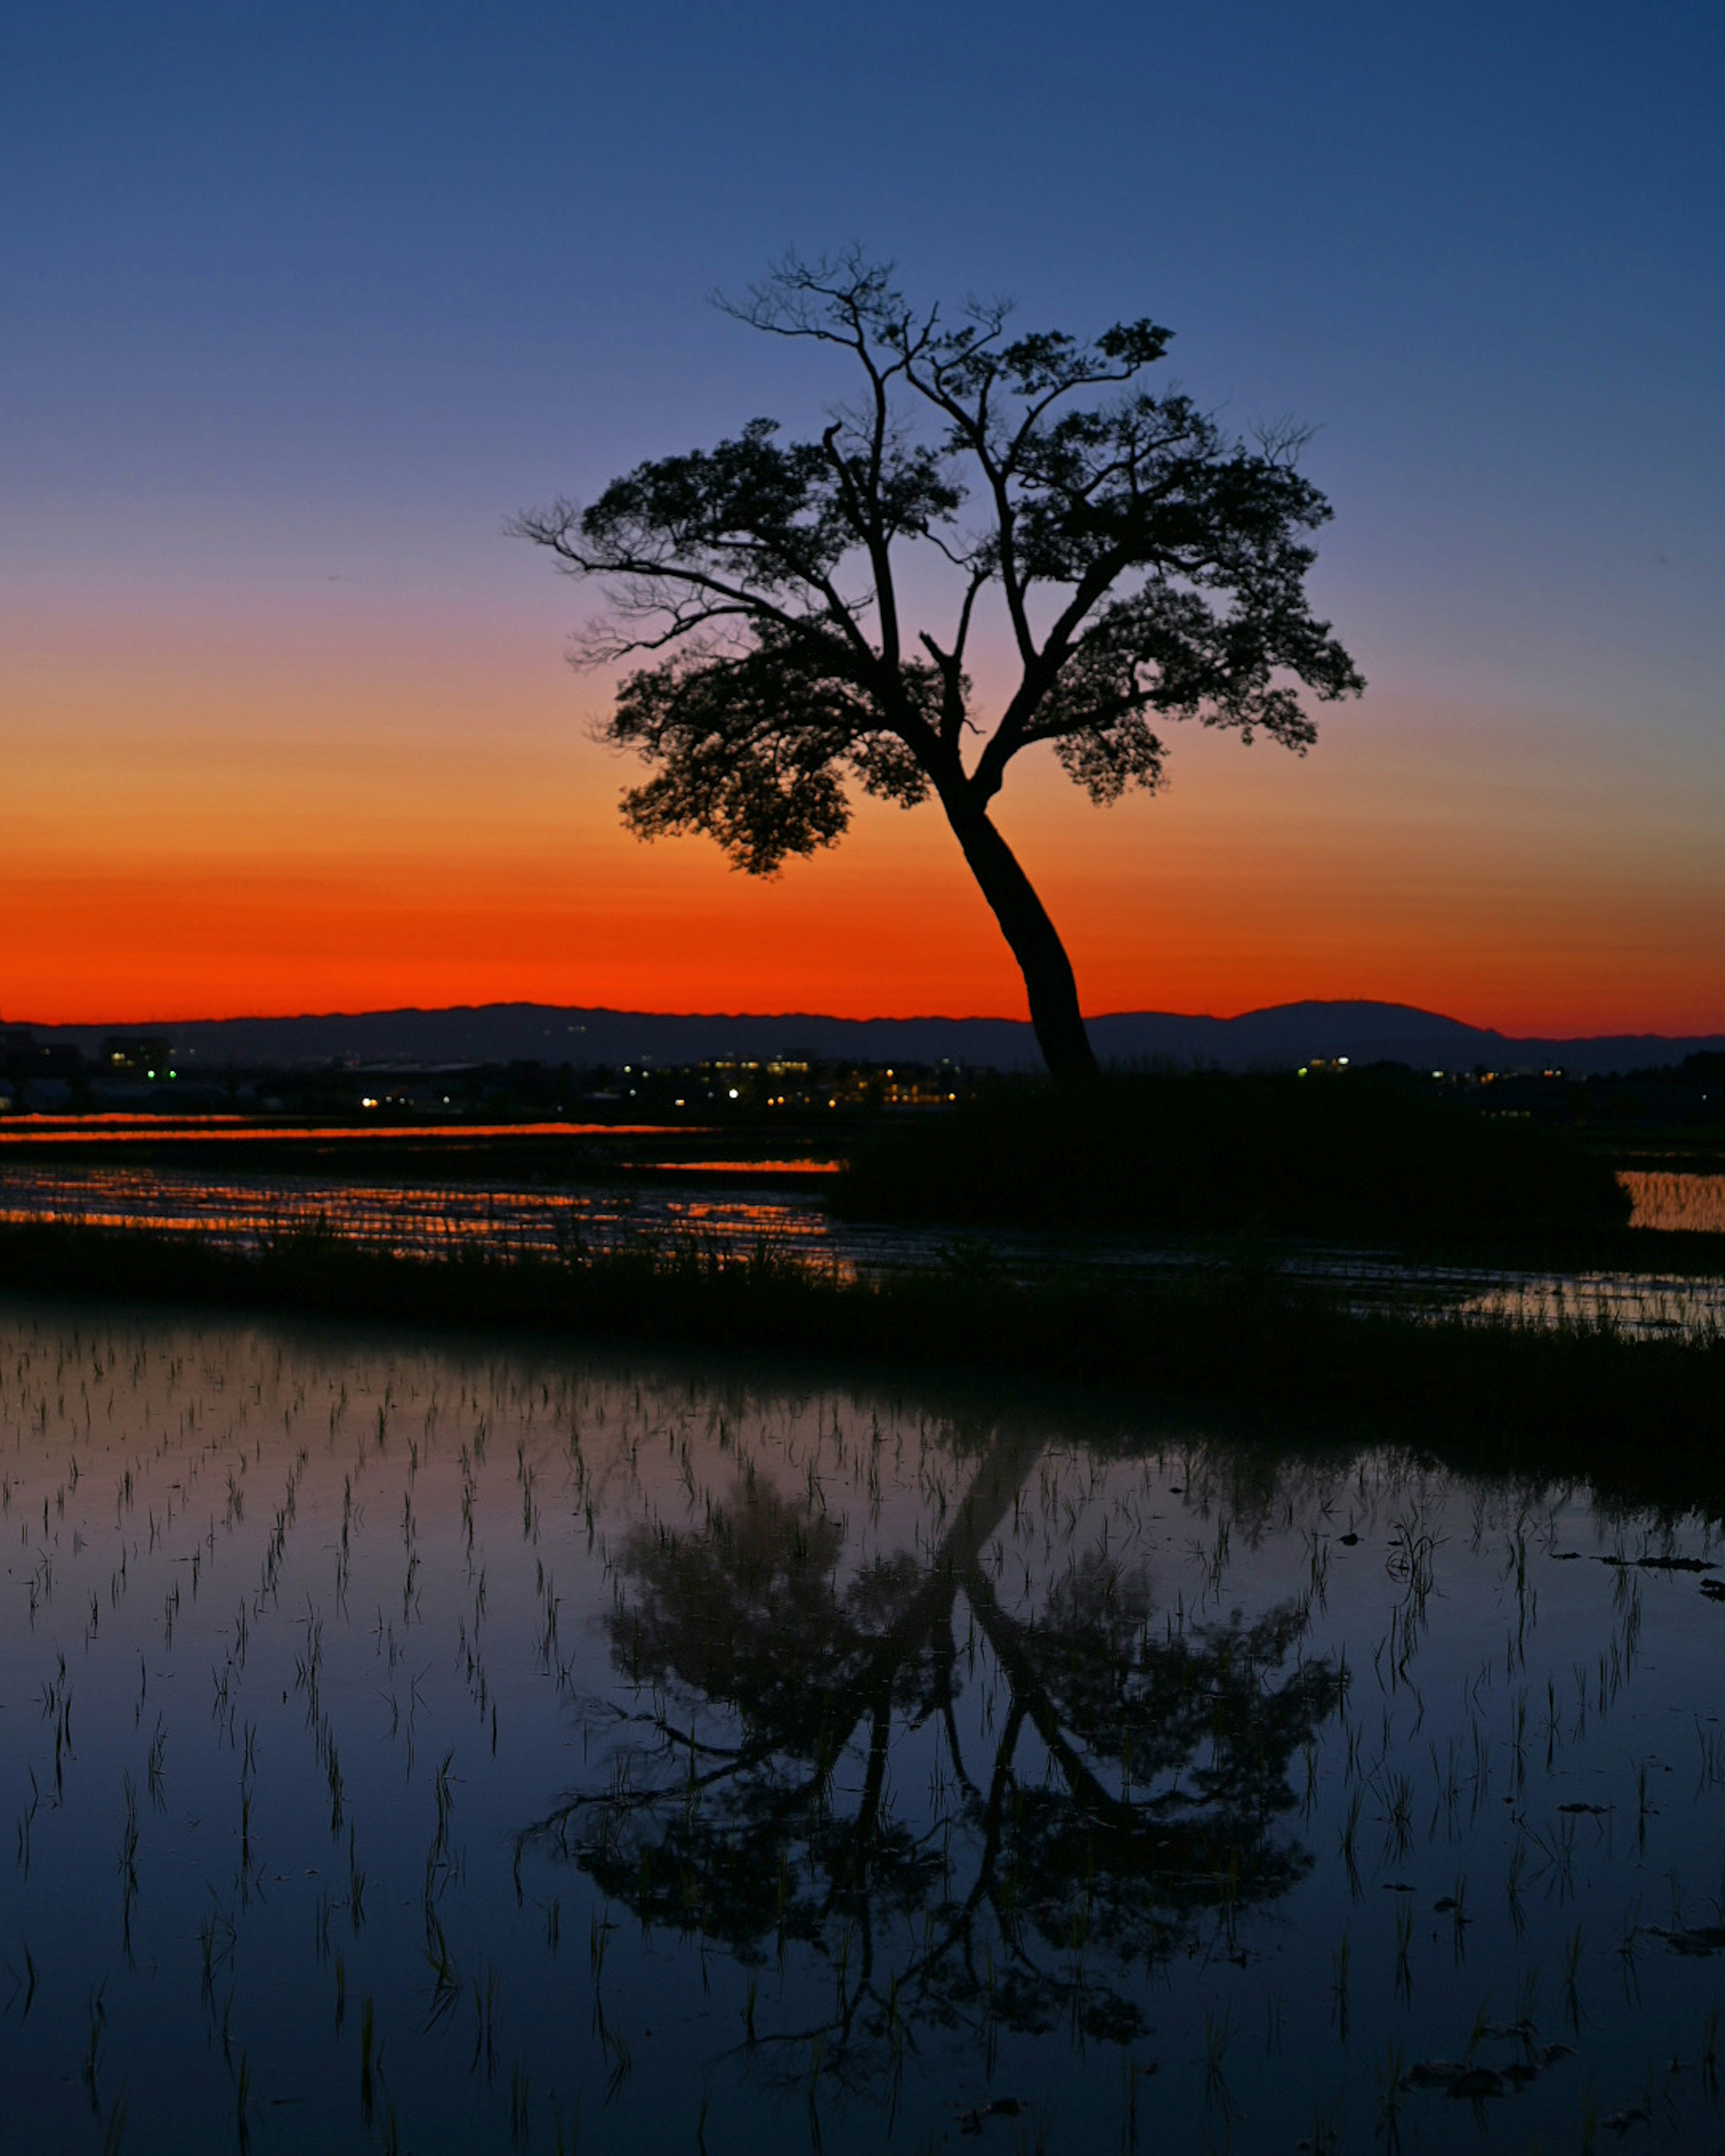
[0,0,1725,1035]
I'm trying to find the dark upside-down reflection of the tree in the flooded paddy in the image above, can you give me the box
[522,1436,1341,2081]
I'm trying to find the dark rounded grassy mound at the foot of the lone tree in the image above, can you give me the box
[832,1072,1630,1244]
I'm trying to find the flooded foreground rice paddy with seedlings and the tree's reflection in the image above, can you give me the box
[0,1304,1725,2156]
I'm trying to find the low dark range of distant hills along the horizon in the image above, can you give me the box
[17,1003,1725,1074]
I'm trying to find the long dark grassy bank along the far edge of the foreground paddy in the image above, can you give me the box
[0,1224,1725,1511]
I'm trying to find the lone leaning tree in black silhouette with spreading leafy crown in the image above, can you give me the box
[513,252,1365,1078]
